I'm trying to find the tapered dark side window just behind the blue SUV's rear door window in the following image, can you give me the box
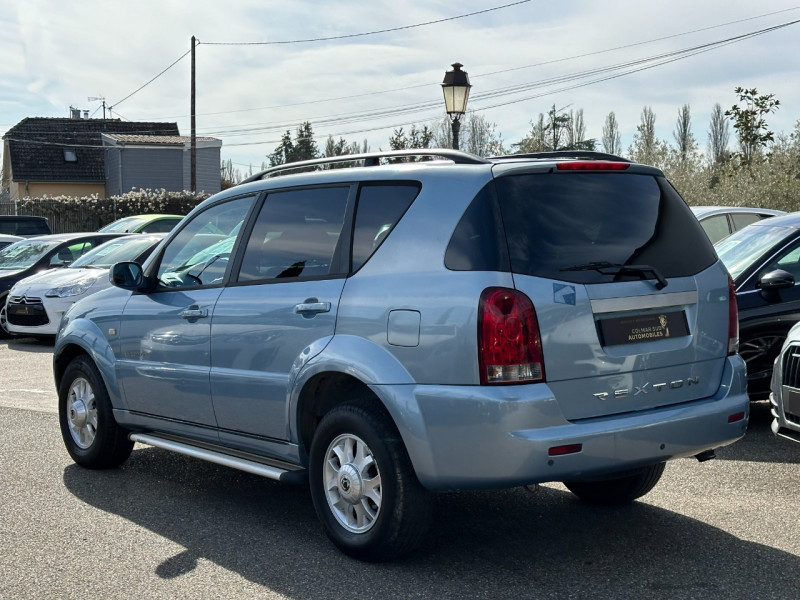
[352,182,420,271]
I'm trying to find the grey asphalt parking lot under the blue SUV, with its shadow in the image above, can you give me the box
[0,339,800,600]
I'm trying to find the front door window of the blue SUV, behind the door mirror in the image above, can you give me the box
[158,196,255,288]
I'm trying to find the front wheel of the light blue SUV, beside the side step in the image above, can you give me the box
[58,356,133,469]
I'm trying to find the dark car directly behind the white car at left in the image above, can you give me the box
[0,231,130,338]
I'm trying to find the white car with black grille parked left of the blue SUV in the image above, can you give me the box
[6,233,165,337]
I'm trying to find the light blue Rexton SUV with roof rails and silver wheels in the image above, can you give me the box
[54,150,749,560]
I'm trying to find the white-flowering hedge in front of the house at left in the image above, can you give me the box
[8,189,208,233]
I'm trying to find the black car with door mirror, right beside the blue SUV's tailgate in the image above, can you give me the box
[715,212,800,399]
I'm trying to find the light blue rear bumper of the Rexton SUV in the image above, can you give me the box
[376,356,750,490]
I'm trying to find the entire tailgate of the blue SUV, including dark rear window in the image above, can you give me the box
[495,161,729,419]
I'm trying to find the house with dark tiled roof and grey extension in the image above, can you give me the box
[2,117,222,200]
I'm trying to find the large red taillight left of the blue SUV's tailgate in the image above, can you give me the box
[478,288,544,384]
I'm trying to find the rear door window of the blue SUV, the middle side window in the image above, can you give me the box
[239,186,350,281]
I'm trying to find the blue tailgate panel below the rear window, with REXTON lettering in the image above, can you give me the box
[515,263,728,420]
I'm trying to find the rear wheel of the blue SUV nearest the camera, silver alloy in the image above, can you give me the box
[309,400,433,562]
